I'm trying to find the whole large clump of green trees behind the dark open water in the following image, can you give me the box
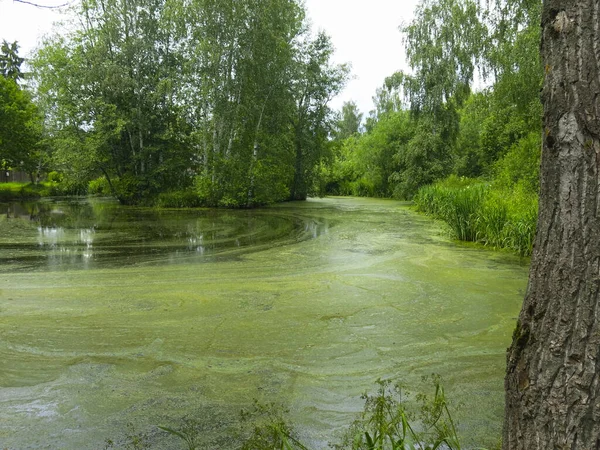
[33,0,347,207]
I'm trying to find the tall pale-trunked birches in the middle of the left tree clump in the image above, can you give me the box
[186,0,304,206]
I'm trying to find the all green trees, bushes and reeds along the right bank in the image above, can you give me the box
[321,0,542,243]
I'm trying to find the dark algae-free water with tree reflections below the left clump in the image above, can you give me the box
[0,199,329,271]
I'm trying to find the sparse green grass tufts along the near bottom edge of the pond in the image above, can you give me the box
[105,376,478,450]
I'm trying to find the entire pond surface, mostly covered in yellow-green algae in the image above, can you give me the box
[0,198,527,449]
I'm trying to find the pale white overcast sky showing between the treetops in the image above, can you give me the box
[0,0,417,115]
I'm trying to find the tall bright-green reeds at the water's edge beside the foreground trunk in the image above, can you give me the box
[414,177,538,256]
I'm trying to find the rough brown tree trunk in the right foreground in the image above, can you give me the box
[503,0,600,450]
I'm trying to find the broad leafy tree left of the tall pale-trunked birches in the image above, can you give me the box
[34,0,190,203]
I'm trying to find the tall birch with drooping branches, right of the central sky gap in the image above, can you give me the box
[388,0,487,198]
